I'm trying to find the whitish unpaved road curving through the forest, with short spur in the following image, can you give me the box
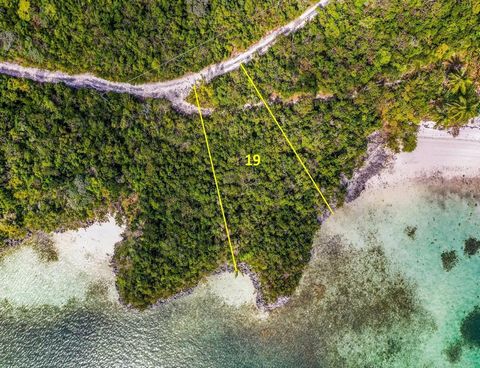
[0,0,329,114]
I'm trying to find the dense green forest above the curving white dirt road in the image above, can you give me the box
[0,0,314,82]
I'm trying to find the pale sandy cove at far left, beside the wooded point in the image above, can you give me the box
[0,217,124,306]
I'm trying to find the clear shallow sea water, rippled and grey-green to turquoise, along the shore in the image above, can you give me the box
[0,180,480,368]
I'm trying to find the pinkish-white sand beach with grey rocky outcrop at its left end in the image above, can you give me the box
[346,118,480,198]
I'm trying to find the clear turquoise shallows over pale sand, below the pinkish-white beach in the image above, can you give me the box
[320,183,480,367]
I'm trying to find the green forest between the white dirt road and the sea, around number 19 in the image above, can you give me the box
[0,0,480,308]
